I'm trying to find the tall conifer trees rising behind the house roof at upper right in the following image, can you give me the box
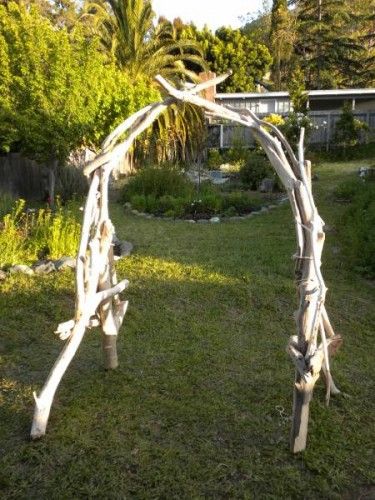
[247,0,375,90]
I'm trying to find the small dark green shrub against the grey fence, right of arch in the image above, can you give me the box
[334,103,368,157]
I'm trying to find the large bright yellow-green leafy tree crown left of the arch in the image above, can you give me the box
[0,2,159,160]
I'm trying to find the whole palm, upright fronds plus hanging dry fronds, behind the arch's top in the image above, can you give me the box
[83,0,207,161]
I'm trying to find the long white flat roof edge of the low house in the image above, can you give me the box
[215,89,375,100]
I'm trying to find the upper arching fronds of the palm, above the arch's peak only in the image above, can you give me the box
[84,0,206,81]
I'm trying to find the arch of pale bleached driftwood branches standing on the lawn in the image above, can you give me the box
[31,75,340,452]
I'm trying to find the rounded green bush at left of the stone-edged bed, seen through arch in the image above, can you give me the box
[123,165,194,201]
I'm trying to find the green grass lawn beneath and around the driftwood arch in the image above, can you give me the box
[0,161,375,499]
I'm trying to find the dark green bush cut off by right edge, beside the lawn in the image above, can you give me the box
[335,179,375,278]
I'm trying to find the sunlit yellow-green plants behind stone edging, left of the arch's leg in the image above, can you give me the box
[0,200,81,268]
